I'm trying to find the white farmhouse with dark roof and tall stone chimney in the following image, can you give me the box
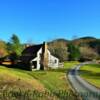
[21,42,59,70]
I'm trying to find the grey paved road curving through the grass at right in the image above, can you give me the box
[68,63,100,100]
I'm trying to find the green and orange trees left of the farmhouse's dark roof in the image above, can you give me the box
[0,34,24,61]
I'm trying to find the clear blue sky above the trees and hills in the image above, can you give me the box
[0,0,100,43]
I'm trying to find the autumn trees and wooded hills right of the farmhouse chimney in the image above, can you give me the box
[48,37,100,61]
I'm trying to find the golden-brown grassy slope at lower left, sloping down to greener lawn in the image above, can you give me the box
[0,66,44,91]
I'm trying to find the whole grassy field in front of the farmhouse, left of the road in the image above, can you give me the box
[0,62,78,100]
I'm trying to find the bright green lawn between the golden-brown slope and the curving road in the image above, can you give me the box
[27,62,78,90]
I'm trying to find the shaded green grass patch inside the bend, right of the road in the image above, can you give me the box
[80,64,100,88]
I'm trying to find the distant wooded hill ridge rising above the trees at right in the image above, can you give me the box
[48,36,100,53]
